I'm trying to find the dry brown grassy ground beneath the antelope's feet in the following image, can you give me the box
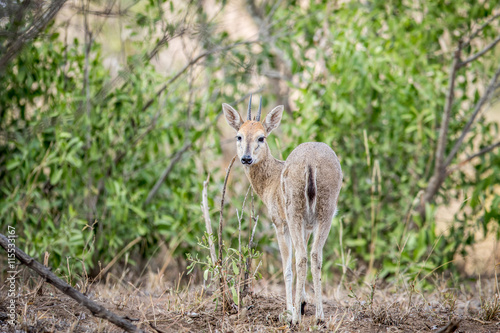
[0,272,500,332]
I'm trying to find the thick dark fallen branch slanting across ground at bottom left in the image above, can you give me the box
[0,234,143,333]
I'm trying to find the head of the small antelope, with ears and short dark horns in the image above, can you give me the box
[222,95,283,166]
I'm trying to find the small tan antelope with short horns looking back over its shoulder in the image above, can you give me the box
[222,96,342,324]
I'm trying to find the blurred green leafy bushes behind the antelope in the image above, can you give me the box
[0,0,500,277]
